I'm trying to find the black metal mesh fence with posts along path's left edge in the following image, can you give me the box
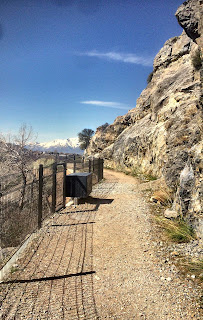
[0,156,103,267]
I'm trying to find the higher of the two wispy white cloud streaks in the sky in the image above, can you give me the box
[82,51,153,67]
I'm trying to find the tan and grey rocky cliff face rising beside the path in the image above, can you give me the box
[87,0,203,238]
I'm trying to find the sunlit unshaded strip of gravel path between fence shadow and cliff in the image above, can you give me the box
[94,170,200,320]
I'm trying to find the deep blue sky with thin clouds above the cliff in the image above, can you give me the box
[0,0,183,142]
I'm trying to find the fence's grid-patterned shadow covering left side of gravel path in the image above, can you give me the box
[0,199,103,320]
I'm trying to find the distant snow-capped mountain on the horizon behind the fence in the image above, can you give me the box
[27,138,83,154]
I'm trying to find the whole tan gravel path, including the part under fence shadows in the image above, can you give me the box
[0,170,201,320]
